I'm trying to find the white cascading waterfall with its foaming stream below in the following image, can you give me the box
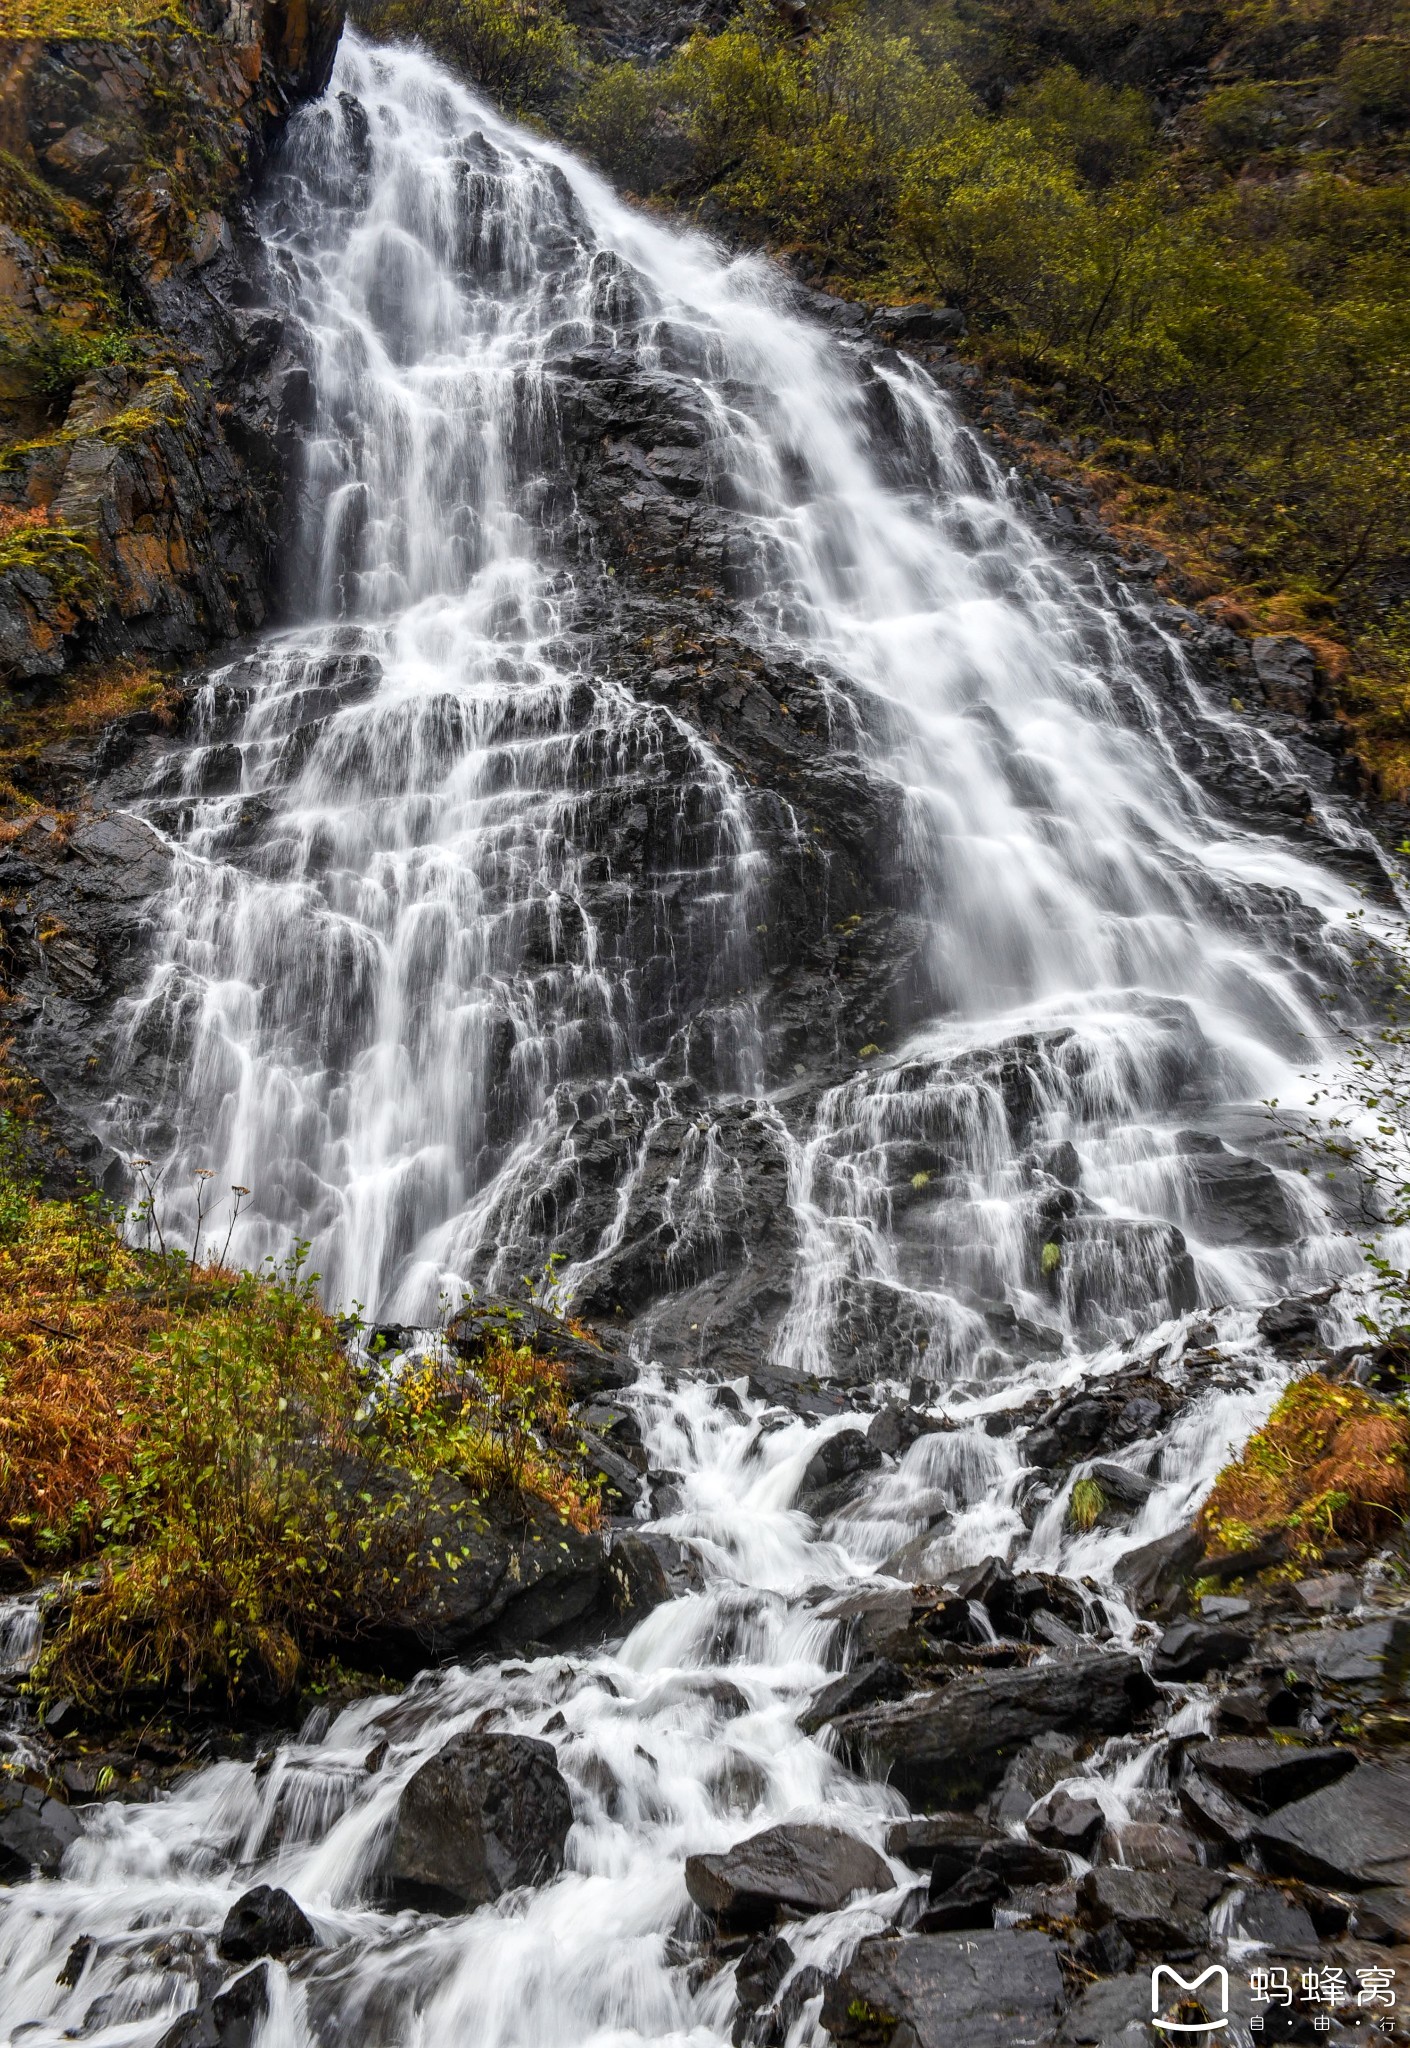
[0,37,1393,2048]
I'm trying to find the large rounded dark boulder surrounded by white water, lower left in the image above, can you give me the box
[367,1735,572,1913]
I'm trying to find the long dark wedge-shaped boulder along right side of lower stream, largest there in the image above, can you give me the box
[832,1651,1154,1806]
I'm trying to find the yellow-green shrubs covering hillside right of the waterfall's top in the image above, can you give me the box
[357,0,1410,791]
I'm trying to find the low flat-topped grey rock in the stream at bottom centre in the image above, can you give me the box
[685,1823,896,1927]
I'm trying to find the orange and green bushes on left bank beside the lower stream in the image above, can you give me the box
[0,1110,598,1708]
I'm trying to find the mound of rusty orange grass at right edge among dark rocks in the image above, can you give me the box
[1197,1372,1410,1556]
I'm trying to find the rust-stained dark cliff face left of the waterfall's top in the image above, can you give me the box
[0,0,342,686]
